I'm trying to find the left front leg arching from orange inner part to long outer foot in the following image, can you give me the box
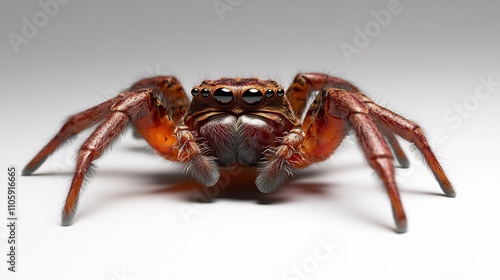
[62,84,219,225]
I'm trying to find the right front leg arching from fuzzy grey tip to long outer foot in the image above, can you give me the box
[257,87,407,232]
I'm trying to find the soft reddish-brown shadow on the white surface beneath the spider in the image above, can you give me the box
[31,165,333,219]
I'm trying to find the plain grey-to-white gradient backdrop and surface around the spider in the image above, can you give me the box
[0,0,500,280]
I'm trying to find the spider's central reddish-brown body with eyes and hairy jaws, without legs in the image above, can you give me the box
[188,78,298,166]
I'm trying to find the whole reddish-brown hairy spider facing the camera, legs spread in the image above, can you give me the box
[23,73,455,233]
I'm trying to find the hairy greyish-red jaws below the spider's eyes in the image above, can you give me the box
[199,115,281,166]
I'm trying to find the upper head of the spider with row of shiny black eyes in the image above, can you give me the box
[185,78,294,127]
